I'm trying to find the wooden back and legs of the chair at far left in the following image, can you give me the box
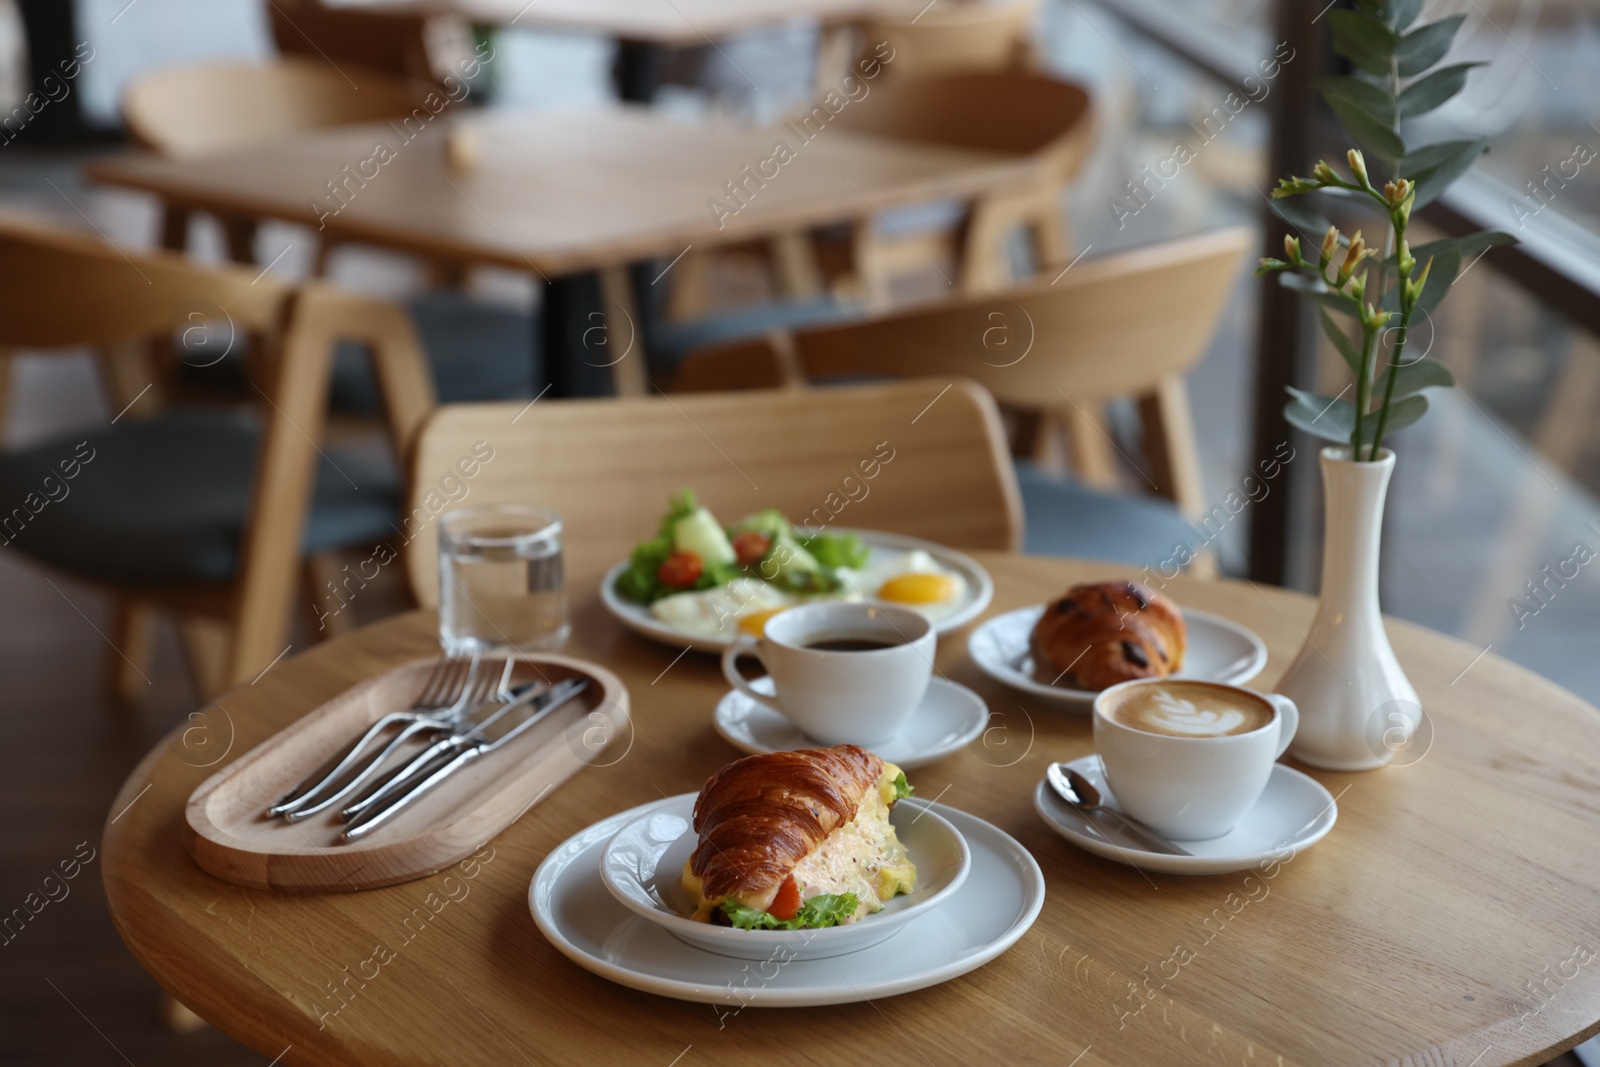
[0,214,434,683]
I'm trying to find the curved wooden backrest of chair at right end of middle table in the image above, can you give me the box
[834,70,1093,179]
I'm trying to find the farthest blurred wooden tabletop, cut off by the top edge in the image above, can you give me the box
[336,0,922,45]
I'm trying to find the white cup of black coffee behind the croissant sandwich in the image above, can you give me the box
[722,601,938,745]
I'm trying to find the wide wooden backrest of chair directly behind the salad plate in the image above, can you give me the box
[403,378,1021,605]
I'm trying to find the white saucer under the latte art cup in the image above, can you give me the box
[1034,755,1339,875]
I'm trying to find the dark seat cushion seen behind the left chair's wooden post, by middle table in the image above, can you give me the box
[331,290,538,411]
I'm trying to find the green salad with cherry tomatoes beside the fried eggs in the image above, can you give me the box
[616,490,870,605]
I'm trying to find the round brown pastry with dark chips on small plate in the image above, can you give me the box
[1029,582,1187,689]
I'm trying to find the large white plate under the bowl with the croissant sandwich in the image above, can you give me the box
[528,793,1046,1008]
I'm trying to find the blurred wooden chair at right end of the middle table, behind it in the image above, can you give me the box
[824,69,1094,307]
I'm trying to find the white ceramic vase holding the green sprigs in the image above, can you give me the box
[1277,446,1422,771]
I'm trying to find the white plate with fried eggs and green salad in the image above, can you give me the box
[600,490,994,651]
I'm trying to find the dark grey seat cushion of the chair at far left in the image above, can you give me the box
[0,410,398,585]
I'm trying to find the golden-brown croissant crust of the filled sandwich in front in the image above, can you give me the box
[690,745,883,901]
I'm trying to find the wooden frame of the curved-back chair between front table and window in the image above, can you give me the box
[675,229,1254,572]
